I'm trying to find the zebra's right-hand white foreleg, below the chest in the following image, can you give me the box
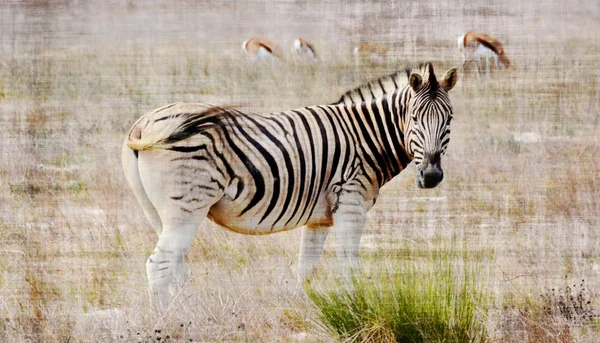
[333,193,367,275]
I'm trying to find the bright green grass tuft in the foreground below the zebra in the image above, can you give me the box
[307,256,489,343]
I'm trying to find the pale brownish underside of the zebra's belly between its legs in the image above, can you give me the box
[208,198,332,235]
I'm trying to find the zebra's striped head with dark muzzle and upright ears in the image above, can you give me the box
[405,63,457,188]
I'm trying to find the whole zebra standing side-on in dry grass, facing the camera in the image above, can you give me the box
[122,63,457,312]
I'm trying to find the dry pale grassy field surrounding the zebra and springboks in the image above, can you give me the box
[0,0,600,342]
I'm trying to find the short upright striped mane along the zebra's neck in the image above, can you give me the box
[333,63,431,105]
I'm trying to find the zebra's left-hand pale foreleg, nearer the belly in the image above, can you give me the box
[298,225,329,283]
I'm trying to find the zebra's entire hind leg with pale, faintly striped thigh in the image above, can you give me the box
[138,149,227,313]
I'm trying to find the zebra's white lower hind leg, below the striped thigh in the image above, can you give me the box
[146,207,209,313]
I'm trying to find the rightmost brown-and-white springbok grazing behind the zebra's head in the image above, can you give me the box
[458,31,512,72]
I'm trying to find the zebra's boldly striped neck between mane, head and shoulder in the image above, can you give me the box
[339,87,412,186]
